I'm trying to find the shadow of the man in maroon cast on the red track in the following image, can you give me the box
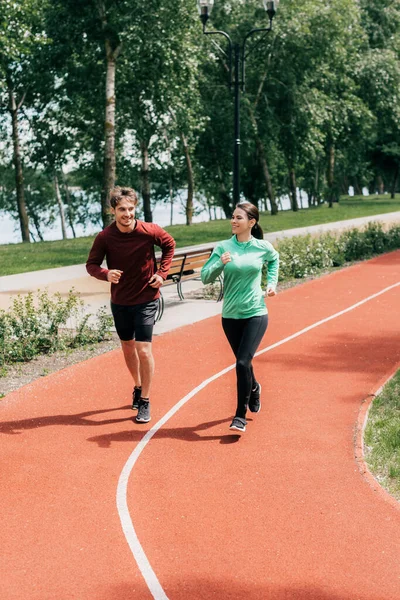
[0,406,132,435]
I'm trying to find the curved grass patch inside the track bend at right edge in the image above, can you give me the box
[364,370,400,500]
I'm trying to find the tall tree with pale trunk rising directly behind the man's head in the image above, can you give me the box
[48,0,136,226]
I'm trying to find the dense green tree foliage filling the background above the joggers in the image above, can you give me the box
[0,0,400,239]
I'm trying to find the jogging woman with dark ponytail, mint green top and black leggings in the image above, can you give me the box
[201,202,279,431]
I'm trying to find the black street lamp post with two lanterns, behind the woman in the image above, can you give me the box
[197,0,279,204]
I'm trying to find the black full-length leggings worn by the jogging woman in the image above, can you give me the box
[222,315,268,419]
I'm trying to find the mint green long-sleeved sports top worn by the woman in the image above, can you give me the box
[201,235,279,319]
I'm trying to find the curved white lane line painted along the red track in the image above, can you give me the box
[117,281,400,600]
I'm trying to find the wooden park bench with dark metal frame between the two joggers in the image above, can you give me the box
[156,247,224,321]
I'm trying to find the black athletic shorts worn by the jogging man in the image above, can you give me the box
[111,299,159,342]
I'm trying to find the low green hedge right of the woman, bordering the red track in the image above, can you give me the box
[277,223,400,280]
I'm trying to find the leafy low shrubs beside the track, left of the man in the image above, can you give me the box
[0,289,112,366]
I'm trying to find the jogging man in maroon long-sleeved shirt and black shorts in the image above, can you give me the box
[86,187,175,423]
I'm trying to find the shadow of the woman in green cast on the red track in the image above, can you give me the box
[88,417,244,448]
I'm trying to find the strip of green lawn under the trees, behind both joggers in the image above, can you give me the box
[0,195,400,276]
